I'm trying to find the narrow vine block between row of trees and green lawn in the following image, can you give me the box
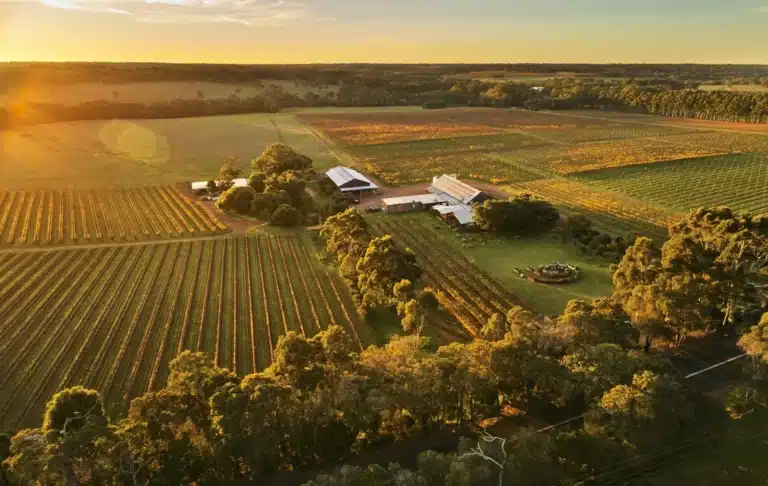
[371,216,522,336]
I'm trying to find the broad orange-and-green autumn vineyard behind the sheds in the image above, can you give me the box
[300,108,748,184]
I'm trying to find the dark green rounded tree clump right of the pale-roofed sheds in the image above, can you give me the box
[474,194,560,236]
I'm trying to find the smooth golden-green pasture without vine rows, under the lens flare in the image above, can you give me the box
[0,114,338,189]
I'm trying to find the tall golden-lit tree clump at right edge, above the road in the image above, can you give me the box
[613,208,768,346]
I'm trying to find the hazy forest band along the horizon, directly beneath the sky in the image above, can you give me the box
[0,63,768,88]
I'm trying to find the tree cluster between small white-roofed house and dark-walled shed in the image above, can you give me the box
[216,144,314,226]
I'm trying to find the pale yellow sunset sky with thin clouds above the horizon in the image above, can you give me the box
[0,0,768,64]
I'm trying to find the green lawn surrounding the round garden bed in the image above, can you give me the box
[400,213,612,315]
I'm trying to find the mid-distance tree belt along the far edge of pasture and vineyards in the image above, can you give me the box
[0,65,768,127]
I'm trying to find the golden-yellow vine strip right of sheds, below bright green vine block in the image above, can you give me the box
[504,178,682,239]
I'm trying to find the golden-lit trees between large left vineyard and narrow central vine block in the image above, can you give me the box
[320,208,421,309]
